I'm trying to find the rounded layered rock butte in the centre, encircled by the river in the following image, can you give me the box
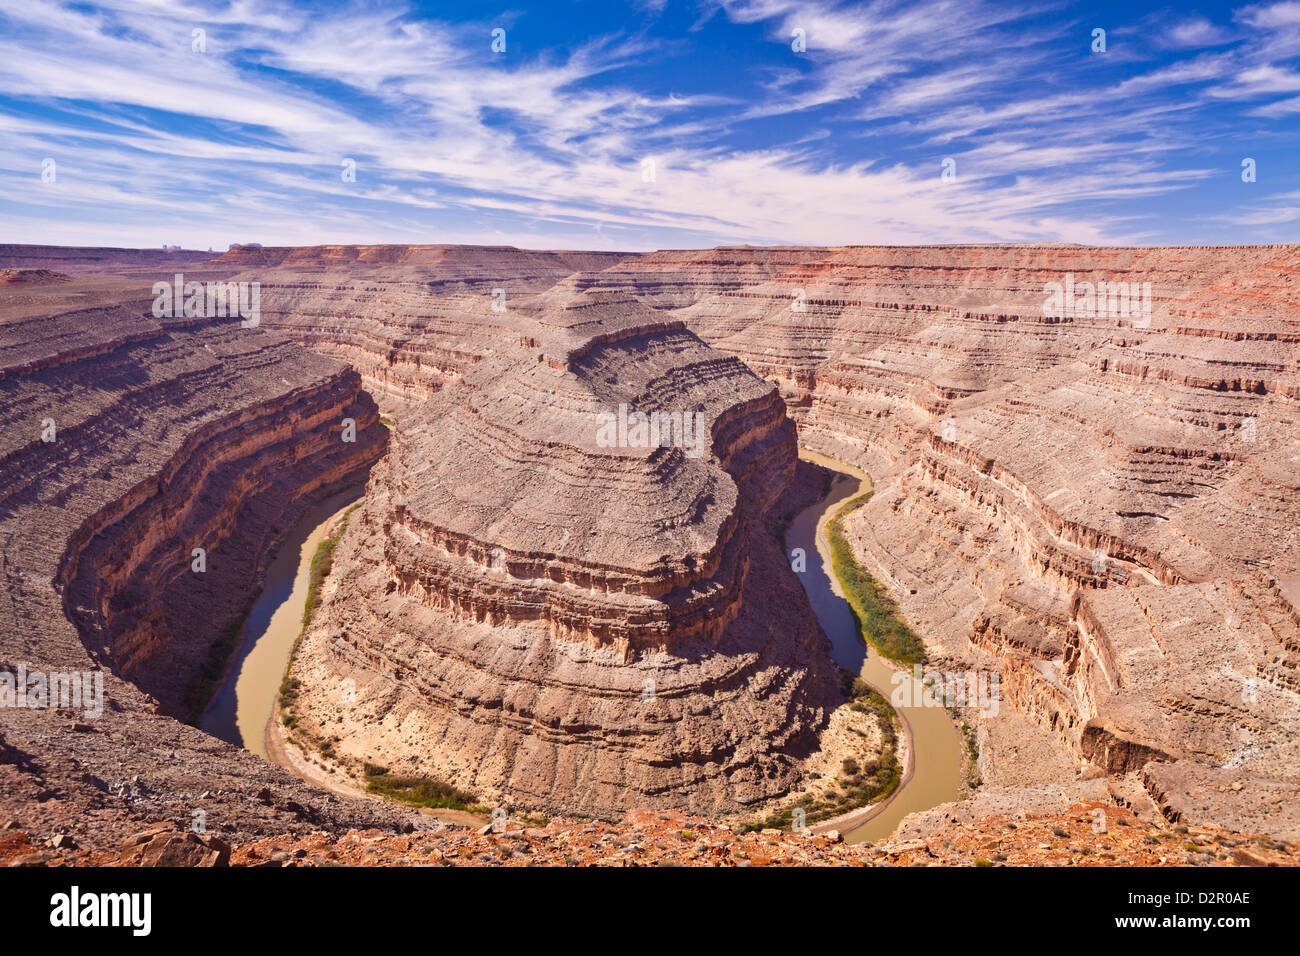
[284,293,841,817]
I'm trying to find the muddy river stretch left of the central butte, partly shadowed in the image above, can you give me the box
[199,486,365,757]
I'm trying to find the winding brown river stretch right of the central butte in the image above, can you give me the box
[785,450,962,843]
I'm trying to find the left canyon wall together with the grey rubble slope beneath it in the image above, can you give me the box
[0,267,403,843]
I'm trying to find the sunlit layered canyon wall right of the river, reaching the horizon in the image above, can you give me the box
[239,246,1300,832]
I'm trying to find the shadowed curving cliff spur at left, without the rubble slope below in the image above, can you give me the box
[0,287,386,715]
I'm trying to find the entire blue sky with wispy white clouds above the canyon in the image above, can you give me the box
[0,0,1300,251]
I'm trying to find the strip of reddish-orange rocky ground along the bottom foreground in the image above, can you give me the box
[0,803,1300,868]
